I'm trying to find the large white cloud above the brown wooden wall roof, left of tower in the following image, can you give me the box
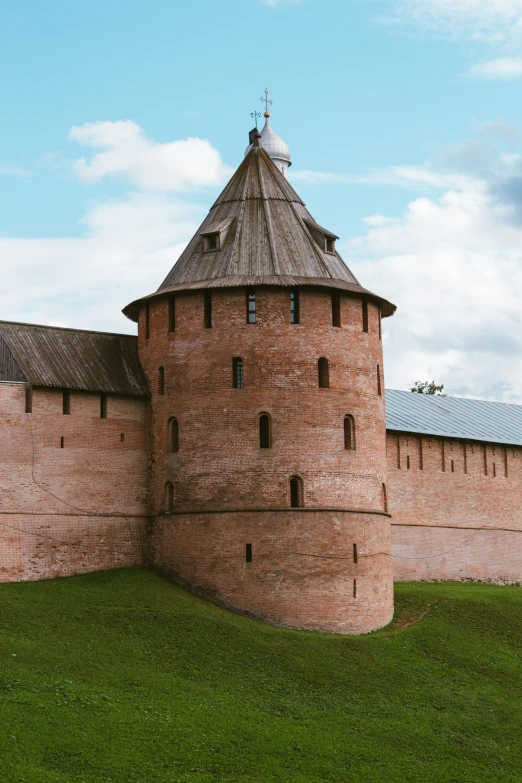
[0,193,206,332]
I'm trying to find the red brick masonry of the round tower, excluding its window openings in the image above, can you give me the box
[139,288,393,633]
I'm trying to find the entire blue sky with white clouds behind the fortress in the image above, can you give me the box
[0,0,522,401]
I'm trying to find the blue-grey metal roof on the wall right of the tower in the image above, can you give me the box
[386,389,522,446]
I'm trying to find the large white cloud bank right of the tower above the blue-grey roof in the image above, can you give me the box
[345,179,522,402]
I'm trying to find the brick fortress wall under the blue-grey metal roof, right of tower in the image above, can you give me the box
[387,432,522,583]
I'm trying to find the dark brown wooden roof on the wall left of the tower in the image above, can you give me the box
[0,321,149,396]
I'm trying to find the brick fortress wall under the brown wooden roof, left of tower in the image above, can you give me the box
[0,383,148,581]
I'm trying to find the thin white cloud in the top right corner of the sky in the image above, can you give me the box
[395,0,522,43]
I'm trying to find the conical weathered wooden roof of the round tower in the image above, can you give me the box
[123,146,395,320]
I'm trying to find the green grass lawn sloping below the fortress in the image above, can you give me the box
[0,569,522,783]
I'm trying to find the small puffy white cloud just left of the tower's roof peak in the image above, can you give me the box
[69,120,230,192]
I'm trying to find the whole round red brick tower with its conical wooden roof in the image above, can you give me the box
[124,116,395,633]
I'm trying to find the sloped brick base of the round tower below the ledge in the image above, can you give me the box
[152,509,393,634]
